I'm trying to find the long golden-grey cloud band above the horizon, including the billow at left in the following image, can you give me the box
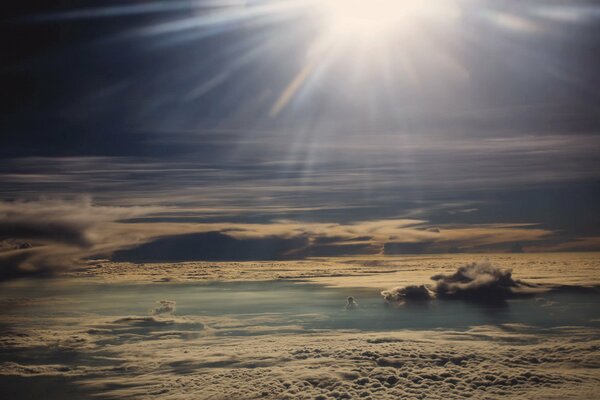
[0,197,568,280]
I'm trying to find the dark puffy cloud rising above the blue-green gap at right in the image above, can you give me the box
[381,261,544,302]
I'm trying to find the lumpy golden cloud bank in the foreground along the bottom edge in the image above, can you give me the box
[0,326,598,399]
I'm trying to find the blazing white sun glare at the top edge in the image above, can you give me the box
[269,0,468,118]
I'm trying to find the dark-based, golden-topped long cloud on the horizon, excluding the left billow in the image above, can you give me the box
[112,219,551,262]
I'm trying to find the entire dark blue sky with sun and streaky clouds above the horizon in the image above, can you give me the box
[0,0,600,279]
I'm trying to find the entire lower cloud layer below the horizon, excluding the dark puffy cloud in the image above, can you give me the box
[0,254,600,399]
